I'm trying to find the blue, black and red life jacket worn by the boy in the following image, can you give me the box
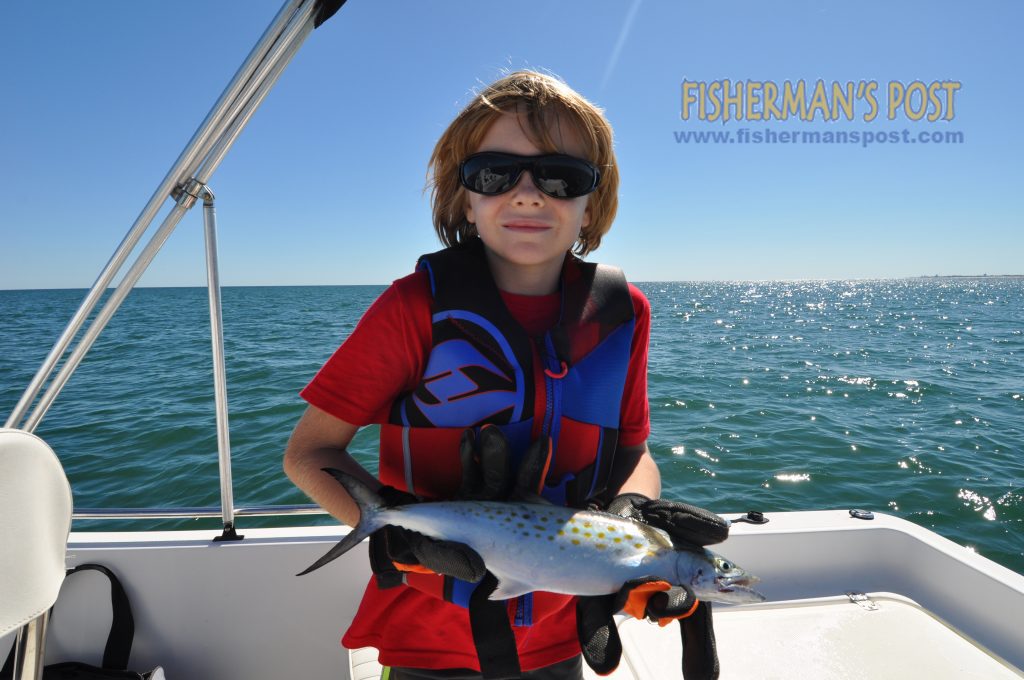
[379,239,634,614]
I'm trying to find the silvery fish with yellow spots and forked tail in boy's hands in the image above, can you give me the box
[300,469,765,604]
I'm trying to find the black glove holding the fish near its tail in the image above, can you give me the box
[370,486,486,589]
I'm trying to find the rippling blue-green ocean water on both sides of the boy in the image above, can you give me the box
[0,278,1024,571]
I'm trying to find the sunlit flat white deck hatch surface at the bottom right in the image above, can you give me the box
[351,593,1024,680]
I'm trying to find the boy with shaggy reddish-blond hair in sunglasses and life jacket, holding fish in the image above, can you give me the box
[285,72,710,680]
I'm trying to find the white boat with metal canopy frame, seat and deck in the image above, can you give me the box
[0,0,1024,680]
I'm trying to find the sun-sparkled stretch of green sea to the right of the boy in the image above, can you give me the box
[644,278,1024,570]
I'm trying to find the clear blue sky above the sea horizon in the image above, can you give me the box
[0,0,1024,289]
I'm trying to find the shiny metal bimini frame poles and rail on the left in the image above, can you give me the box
[5,0,345,539]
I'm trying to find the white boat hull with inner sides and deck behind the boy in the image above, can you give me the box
[0,511,1024,680]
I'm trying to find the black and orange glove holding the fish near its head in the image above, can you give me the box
[577,494,729,680]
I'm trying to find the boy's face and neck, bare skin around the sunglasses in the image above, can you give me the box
[466,114,590,295]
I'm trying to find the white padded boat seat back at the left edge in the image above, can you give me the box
[0,428,72,637]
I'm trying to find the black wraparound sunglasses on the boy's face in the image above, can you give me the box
[459,152,601,199]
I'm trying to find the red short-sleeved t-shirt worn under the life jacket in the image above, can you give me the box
[301,272,650,671]
